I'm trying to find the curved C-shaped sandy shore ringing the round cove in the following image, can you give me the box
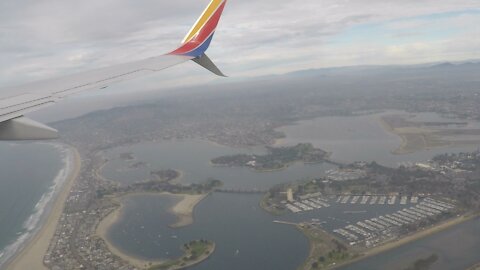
[95,192,208,269]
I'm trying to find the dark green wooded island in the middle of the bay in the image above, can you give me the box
[211,143,330,171]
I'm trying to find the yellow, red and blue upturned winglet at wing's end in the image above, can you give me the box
[169,0,227,76]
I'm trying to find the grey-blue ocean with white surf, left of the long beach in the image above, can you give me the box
[0,143,72,268]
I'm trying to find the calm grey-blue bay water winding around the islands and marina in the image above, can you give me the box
[102,111,480,270]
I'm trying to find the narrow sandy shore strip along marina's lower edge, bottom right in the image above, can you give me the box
[327,214,479,269]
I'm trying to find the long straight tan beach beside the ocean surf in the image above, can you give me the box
[6,148,81,270]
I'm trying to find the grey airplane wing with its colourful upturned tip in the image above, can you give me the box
[0,0,226,140]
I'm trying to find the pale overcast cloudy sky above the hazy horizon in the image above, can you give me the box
[0,0,480,88]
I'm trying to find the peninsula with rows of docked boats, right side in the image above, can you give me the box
[261,151,480,270]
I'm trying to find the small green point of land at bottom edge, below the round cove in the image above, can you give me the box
[148,239,215,270]
